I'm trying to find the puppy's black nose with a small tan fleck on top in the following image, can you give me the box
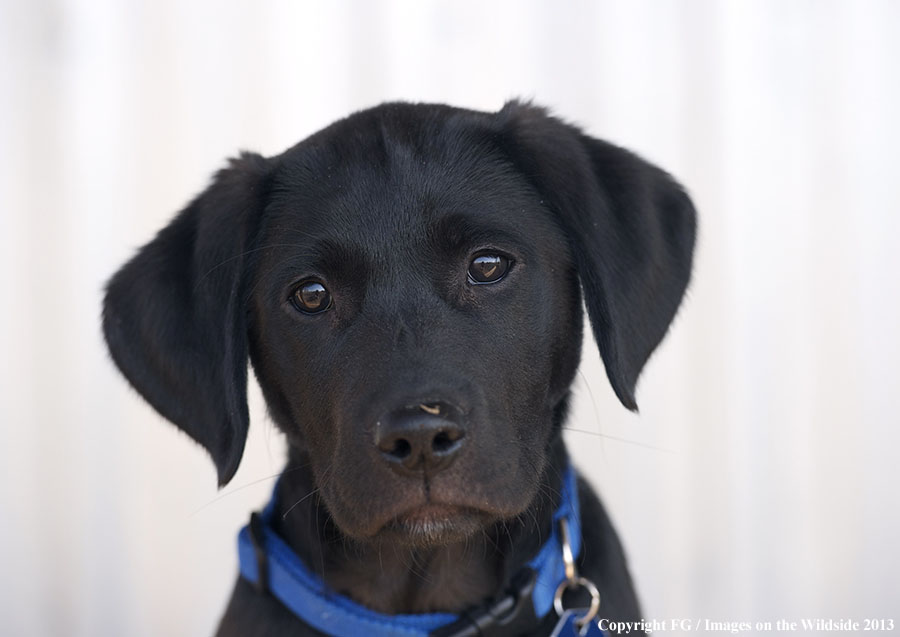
[375,402,466,474]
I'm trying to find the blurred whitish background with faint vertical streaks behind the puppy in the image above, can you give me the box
[0,0,900,637]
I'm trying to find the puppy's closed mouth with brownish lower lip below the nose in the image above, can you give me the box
[379,503,492,546]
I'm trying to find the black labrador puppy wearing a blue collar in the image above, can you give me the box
[103,101,696,637]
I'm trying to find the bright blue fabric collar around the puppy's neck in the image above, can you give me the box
[238,467,581,637]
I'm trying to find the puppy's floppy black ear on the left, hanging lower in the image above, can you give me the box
[103,153,270,486]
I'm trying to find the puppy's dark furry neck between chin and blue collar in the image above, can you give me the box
[273,436,566,614]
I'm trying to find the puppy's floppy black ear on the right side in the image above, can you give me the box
[497,102,697,410]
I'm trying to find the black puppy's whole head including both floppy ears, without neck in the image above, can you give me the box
[104,102,695,544]
